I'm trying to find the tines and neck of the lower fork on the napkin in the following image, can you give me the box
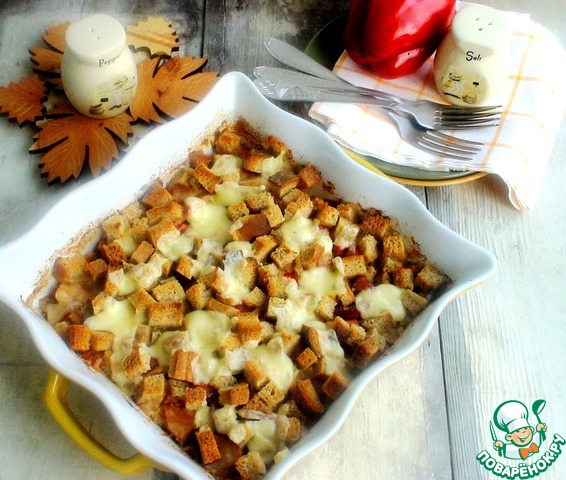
[385,108,483,161]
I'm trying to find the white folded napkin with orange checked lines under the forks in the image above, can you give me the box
[309,2,566,210]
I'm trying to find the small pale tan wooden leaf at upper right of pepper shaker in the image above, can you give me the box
[126,17,179,57]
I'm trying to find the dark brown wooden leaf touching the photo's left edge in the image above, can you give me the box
[0,77,47,126]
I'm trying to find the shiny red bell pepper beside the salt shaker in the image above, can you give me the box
[344,0,456,78]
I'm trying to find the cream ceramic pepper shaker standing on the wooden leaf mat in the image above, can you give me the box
[61,14,138,118]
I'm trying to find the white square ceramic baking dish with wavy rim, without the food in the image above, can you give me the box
[0,72,496,480]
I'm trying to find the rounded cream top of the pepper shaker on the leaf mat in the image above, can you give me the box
[65,13,126,64]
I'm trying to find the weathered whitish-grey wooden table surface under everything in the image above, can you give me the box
[0,0,566,480]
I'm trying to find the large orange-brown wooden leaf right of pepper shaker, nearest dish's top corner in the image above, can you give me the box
[130,57,218,122]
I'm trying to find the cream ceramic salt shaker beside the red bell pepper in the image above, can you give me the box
[434,4,511,106]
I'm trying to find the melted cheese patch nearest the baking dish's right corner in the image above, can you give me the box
[356,283,407,322]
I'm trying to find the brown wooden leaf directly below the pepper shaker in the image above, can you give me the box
[30,101,133,183]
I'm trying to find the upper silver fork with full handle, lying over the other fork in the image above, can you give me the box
[254,67,501,130]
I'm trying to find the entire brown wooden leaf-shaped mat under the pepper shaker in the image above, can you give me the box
[0,17,218,184]
